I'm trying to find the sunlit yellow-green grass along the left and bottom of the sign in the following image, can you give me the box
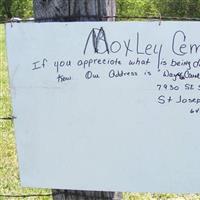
[0,22,200,200]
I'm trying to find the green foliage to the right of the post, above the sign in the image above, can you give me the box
[117,0,200,17]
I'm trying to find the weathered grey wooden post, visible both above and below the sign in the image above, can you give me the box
[33,0,122,200]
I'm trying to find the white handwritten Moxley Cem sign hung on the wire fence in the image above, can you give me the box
[7,22,200,192]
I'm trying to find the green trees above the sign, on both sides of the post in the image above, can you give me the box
[0,0,200,19]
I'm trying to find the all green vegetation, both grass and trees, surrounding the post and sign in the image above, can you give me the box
[0,0,200,200]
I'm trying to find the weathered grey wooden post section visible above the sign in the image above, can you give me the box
[33,0,116,21]
